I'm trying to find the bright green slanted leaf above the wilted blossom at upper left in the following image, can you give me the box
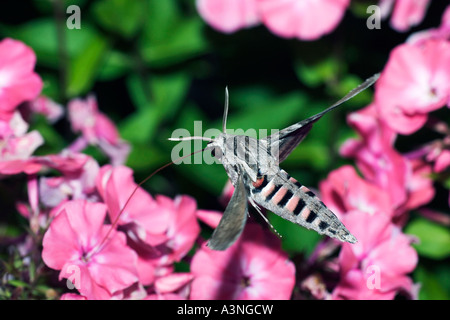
[66,35,109,97]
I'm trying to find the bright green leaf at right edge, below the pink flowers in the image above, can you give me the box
[405,218,450,259]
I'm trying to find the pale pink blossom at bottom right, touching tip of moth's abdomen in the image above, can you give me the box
[332,211,418,299]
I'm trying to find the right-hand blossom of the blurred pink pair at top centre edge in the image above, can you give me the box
[258,0,350,40]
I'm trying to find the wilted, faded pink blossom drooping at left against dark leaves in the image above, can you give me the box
[68,96,130,165]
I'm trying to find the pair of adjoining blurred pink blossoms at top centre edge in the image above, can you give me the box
[197,0,350,40]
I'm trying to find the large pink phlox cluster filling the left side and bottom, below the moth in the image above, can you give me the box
[0,39,295,300]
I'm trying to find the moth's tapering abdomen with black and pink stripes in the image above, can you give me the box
[250,170,357,243]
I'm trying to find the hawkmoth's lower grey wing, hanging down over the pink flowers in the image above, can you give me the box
[208,175,248,250]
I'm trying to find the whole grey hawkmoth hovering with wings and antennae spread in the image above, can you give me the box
[169,74,379,250]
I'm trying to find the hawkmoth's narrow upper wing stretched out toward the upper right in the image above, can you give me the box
[265,73,380,163]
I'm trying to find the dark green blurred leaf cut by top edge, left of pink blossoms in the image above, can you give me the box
[92,0,147,38]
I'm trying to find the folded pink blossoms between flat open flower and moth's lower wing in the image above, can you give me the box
[97,165,200,284]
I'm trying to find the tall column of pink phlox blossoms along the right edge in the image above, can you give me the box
[320,7,450,299]
